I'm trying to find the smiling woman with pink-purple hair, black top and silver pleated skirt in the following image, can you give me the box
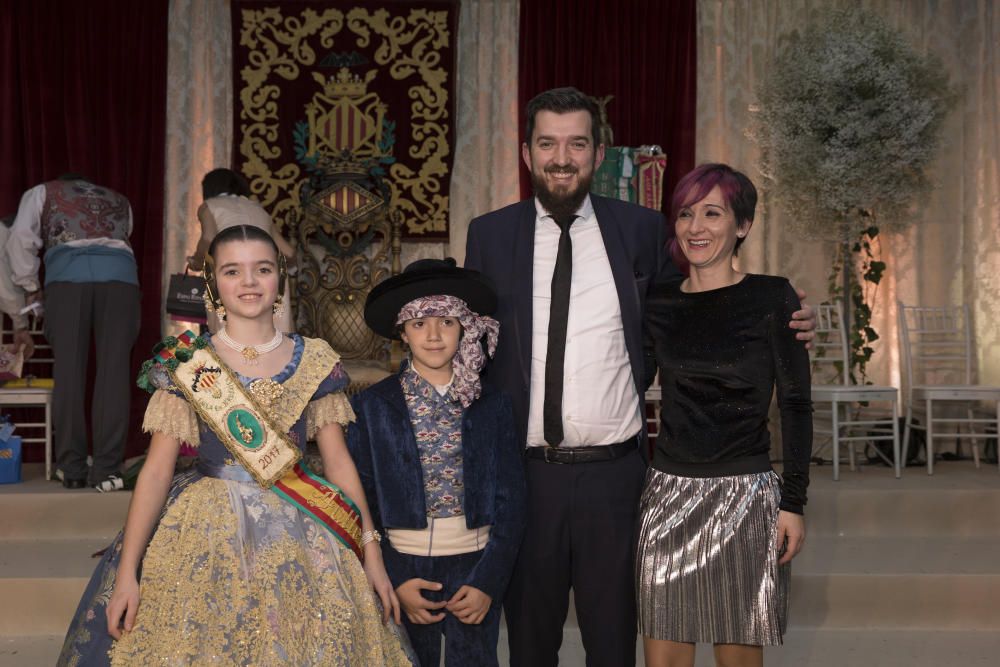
[636,164,812,666]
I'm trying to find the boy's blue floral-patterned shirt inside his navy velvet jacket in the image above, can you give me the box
[400,367,465,519]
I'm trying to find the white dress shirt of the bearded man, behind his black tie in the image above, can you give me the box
[528,196,642,447]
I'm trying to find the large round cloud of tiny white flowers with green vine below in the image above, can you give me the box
[748,10,957,383]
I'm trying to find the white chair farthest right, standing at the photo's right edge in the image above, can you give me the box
[897,301,1000,475]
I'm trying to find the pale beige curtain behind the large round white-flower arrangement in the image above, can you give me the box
[697,0,1000,386]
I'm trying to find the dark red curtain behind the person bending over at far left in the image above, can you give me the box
[0,0,168,460]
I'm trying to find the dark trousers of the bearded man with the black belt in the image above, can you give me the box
[504,450,646,667]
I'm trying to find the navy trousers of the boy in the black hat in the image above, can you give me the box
[382,542,501,667]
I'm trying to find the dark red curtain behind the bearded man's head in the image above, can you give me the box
[518,0,697,224]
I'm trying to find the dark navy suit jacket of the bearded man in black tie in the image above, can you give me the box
[465,194,680,444]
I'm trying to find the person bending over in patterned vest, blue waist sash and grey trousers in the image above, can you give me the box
[7,175,139,491]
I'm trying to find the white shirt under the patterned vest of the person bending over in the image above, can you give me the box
[6,183,134,292]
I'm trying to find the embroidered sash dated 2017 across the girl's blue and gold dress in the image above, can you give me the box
[155,331,362,559]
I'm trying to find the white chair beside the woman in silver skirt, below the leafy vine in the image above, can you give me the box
[812,301,902,480]
